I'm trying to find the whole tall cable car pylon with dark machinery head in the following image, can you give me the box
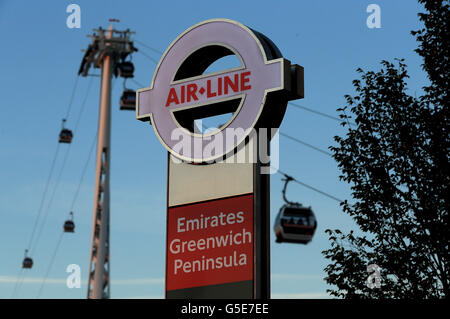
[78,21,136,299]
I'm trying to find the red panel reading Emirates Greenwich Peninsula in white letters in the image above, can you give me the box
[166,194,253,290]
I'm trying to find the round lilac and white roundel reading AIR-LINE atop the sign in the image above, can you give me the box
[136,19,303,163]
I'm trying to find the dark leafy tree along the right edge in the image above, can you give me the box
[323,0,450,299]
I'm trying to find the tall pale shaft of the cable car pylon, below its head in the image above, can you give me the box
[87,26,113,299]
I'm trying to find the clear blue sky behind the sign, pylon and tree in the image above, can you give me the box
[0,0,426,298]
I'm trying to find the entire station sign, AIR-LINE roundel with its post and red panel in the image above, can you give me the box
[136,19,303,299]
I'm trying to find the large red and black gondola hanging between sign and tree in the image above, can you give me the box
[274,176,317,244]
